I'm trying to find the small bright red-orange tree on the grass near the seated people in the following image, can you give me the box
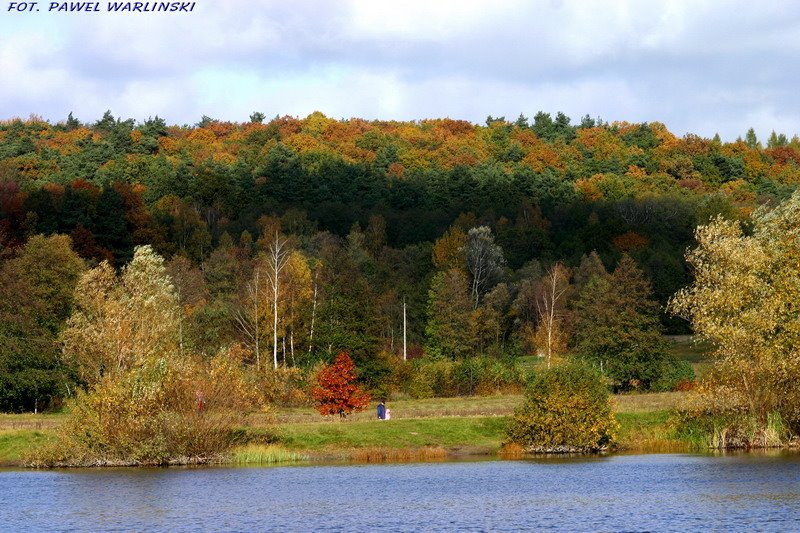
[311,352,371,418]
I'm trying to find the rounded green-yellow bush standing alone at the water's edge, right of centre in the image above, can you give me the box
[506,363,619,453]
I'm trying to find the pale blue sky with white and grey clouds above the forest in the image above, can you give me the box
[0,0,800,141]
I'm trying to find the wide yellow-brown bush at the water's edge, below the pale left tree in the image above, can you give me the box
[30,352,259,466]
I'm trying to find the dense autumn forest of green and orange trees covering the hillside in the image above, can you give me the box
[0,113,800,409]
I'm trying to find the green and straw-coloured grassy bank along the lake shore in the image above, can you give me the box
[0,393,688,465]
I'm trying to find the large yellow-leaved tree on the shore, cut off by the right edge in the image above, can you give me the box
[669,193,800,447]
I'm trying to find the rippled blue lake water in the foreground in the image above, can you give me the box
[0,452,800,531]
